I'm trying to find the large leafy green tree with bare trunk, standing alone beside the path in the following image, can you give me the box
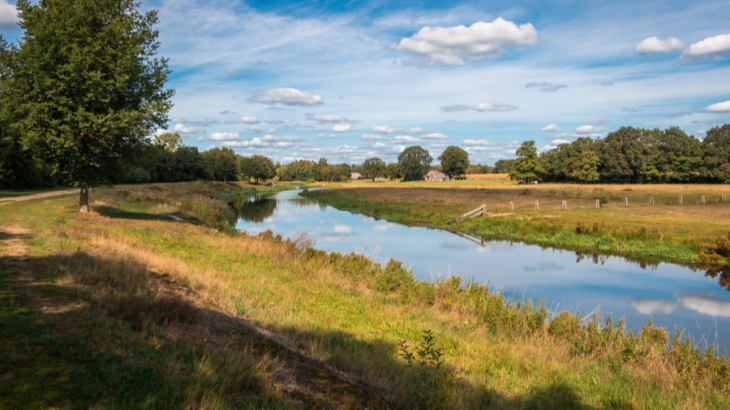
[8,0,174,212]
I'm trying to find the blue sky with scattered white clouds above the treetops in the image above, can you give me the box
[0,0,730,165]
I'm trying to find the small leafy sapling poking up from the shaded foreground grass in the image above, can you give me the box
[400,330,456,409]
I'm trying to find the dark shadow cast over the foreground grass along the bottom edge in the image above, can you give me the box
[0,237,630,410]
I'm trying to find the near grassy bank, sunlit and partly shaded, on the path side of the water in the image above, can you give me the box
[0,183,730,409]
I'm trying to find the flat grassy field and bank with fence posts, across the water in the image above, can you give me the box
[305,179,730,264]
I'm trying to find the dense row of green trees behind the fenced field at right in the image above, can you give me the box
[510,124,730,184]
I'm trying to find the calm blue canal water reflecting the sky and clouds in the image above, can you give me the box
[236,190,730,350]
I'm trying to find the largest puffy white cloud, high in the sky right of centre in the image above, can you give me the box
[390,17,537,65]
